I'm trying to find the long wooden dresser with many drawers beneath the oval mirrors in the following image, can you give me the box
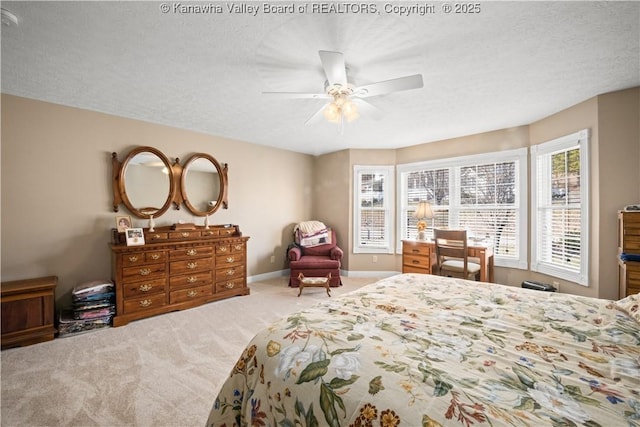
[111,225,249,326]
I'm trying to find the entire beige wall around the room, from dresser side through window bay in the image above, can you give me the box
[1,88,640,299]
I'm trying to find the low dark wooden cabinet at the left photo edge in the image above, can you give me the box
[1,276,58,350]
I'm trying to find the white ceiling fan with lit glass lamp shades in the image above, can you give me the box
[262,50,423,127]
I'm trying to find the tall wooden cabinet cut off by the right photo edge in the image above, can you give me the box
[618,211,640,298]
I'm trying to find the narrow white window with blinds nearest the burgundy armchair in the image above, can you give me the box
[353,166,393,253]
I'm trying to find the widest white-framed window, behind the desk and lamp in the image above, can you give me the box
[397,148,527,268]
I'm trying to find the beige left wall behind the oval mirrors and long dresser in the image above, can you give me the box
[1,94,314,301]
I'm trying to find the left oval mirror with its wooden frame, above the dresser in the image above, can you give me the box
[119,147,174,218]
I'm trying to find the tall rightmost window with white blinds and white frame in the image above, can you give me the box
[531,130,589,286]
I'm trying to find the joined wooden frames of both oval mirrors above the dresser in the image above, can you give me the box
[111,146,229,219]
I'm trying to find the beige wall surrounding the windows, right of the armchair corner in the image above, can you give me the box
[316,88,640,299]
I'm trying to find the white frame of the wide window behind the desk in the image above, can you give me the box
[396,147,529,270]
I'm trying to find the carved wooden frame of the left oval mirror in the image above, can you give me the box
[111,146,176,219]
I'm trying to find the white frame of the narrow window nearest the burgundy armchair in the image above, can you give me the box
[353,165,395,254]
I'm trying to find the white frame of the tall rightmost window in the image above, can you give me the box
[530,129,590,287]
